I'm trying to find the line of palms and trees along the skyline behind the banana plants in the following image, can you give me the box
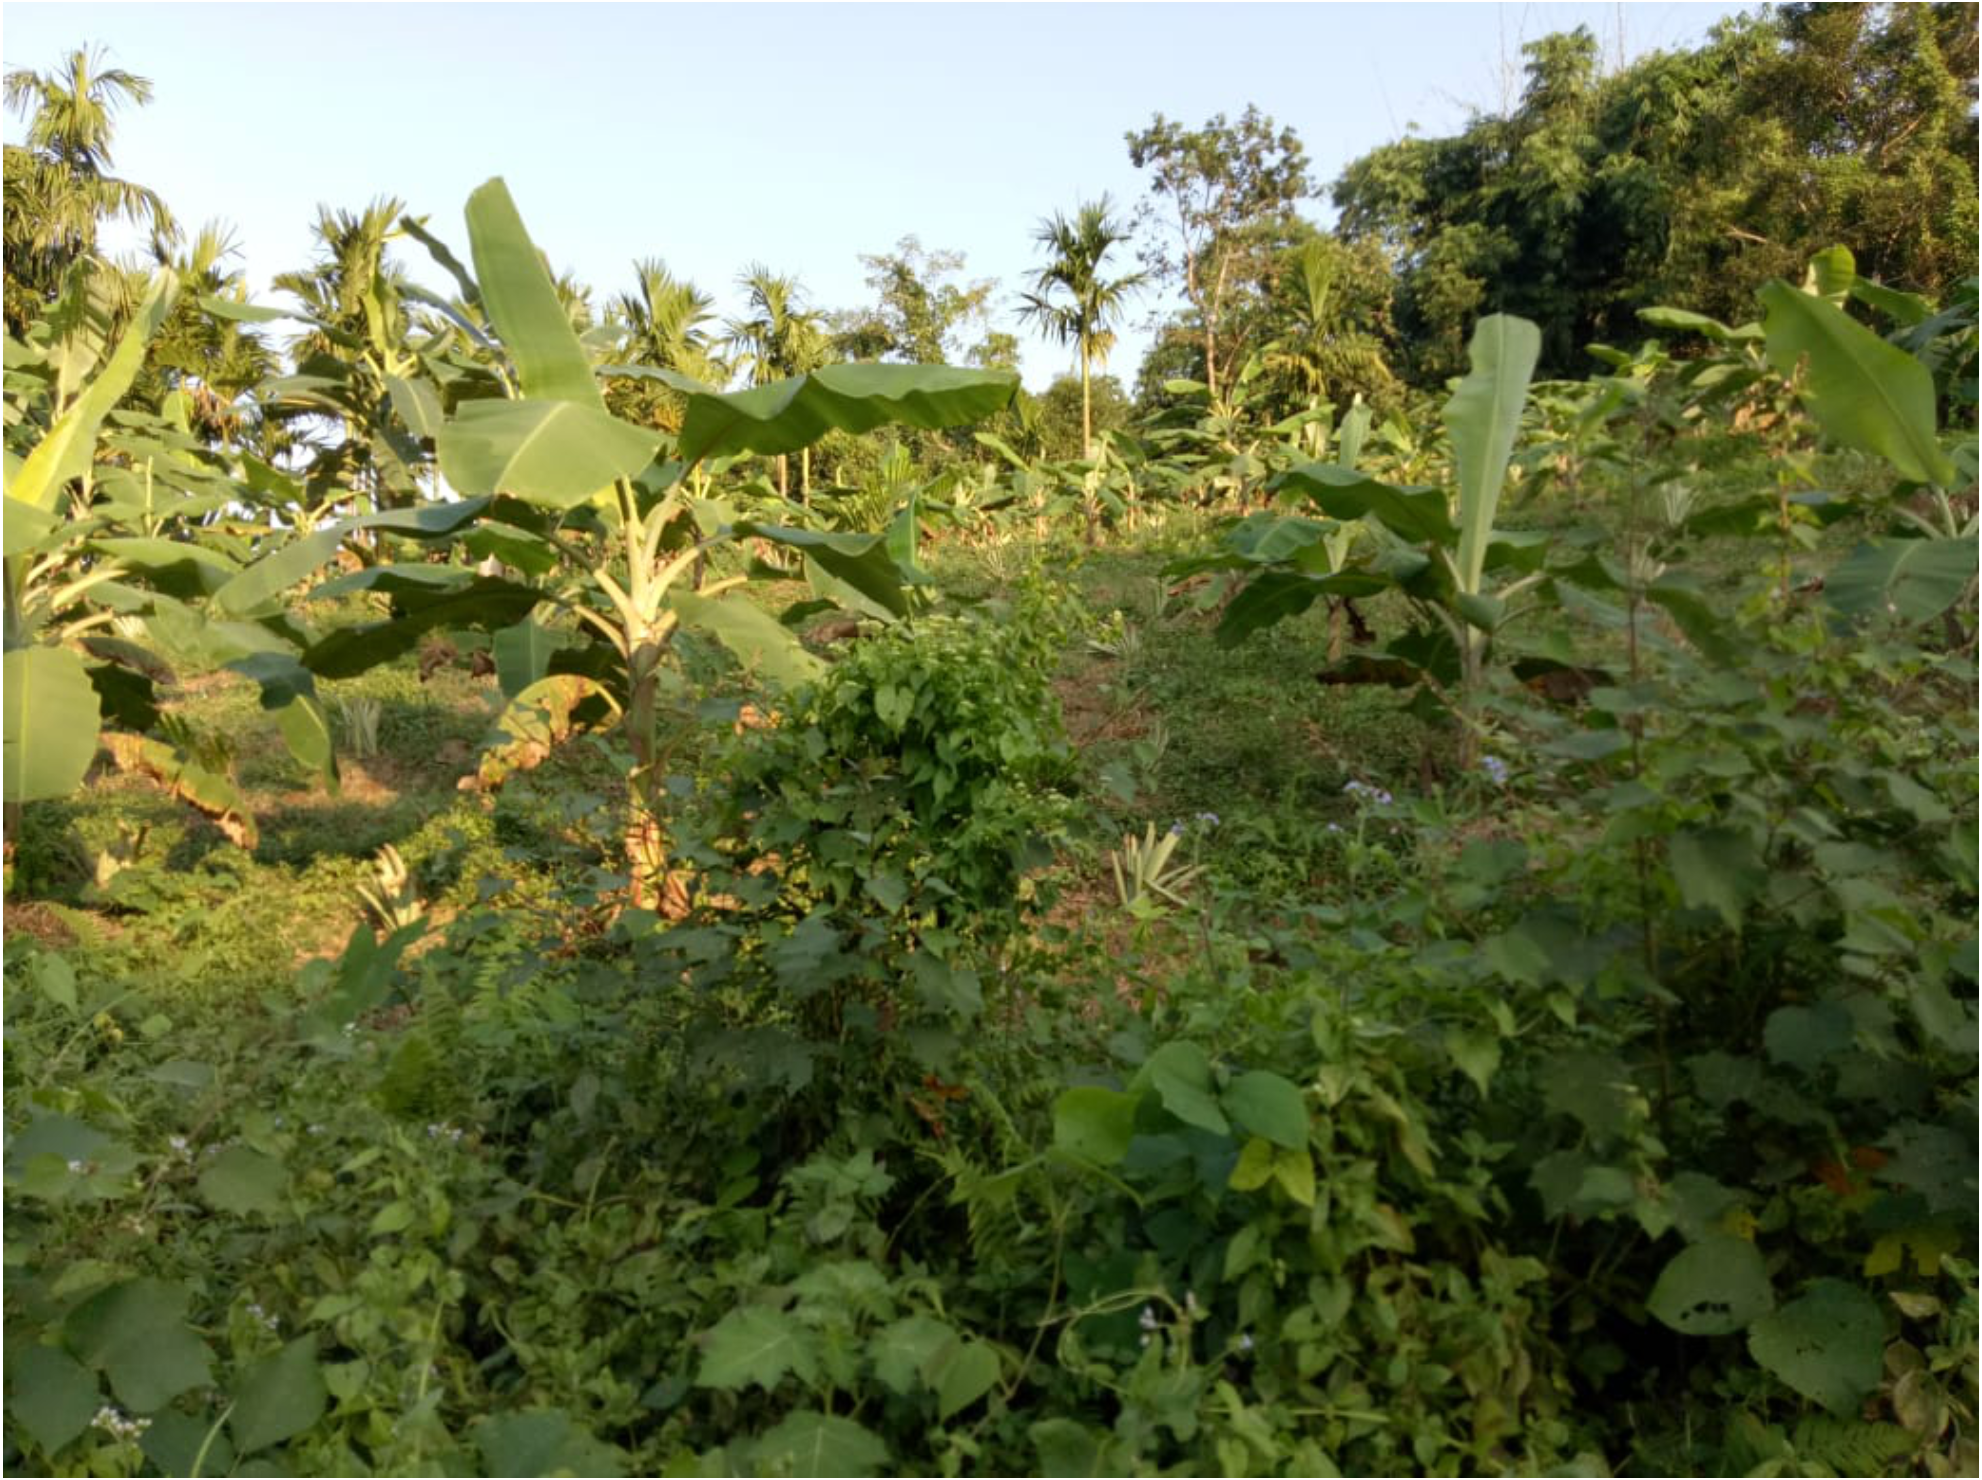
[6,4,1976,469]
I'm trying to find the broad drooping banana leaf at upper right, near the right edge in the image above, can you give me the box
[1760,281,1956,483]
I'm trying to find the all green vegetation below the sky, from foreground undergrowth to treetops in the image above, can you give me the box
[4,6,1978,1476]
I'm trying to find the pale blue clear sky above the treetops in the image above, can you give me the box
[0,0,1754,390]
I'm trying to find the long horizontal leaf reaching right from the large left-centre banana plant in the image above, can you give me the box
[676,365,1019,464]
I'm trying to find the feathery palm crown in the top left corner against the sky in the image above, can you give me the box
[4,48,178,331]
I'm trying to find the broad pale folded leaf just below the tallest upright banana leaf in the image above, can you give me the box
[438,400,660,509]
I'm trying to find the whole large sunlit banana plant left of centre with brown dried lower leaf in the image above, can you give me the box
[247,178,1017,907]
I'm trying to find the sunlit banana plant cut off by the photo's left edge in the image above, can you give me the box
[4,271,350,828]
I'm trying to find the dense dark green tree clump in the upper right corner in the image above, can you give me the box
[1334,6,1976,384]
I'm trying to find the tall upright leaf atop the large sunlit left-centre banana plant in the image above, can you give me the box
[465,176,610,408]
